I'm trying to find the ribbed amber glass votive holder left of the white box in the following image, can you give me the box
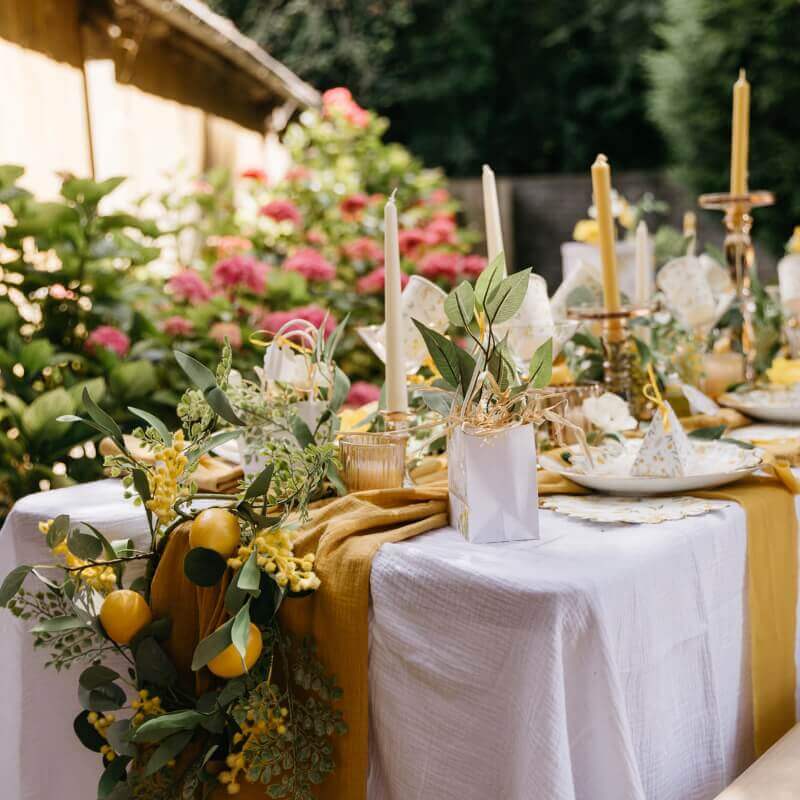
[339,433,408,492]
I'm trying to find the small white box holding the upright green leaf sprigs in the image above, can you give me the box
[447,418,539,544]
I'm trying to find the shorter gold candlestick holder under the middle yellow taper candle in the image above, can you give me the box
[567,306,652,420]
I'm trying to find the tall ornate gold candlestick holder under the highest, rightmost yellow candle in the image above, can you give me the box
[698,190,775,383]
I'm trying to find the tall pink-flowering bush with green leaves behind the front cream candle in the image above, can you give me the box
[152,87,484,383]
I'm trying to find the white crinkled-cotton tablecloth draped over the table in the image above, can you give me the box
[0,462,796,800]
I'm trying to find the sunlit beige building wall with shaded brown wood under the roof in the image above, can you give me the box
[0,0,272,196]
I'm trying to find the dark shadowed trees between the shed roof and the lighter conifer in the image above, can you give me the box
[214,0,664,175]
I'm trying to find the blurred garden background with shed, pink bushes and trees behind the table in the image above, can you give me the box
[0,0,800,509]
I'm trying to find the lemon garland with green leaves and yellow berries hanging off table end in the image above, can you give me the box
[0,348,345,800]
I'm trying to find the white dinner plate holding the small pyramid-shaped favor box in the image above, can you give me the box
[539,439,762,497]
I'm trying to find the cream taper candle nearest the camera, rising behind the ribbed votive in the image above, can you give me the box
[383,192,408,413]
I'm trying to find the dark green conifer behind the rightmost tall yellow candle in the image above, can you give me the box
[645,0,800,252]
